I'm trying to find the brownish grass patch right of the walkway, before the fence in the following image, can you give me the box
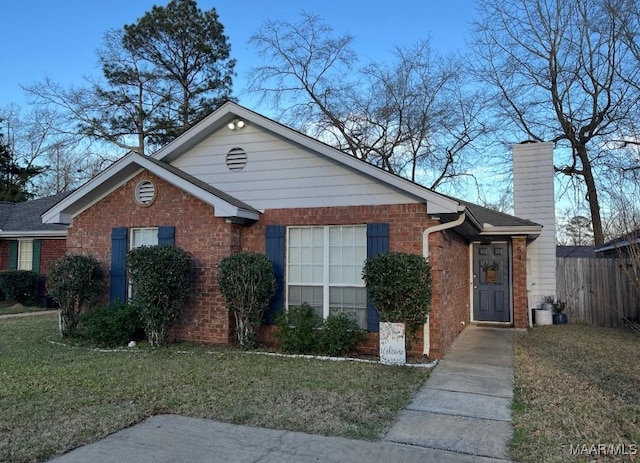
[511,325,640,462]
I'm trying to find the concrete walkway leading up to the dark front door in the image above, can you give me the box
[384,326,514,461]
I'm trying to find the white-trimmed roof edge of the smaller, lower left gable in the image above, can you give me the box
[42,151,260,224]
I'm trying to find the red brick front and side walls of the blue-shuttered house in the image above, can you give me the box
[67,172,478,357]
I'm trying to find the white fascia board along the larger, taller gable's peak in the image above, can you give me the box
[152,102,460,214]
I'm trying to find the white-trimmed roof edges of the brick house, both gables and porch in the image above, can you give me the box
[43,102,541,237]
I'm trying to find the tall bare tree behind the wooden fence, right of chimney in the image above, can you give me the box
[474,0,638,245]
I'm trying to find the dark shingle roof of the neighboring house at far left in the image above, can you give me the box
[0,192,70,232]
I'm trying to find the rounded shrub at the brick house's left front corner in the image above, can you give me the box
[47,254,104,337]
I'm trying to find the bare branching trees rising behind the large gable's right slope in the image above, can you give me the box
[249,13,488,188]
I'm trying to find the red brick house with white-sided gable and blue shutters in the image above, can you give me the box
[43,103,542,357]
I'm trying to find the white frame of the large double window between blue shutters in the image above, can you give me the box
[285,224,367,326]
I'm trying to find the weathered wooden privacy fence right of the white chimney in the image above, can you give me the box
[556,257,640,328]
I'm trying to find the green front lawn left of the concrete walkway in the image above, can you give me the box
[0,315,428,462]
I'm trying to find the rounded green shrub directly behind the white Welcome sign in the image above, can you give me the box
[362,252,432,339]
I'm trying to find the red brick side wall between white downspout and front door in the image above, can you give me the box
[429,230,471,358]
